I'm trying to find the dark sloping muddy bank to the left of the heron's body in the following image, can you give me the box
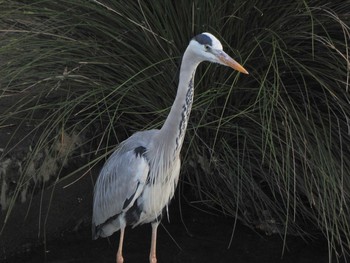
[0,167,97,259]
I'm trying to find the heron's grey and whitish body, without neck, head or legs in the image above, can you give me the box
[93,130,180,238]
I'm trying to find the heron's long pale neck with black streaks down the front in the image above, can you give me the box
[160,50,199,155]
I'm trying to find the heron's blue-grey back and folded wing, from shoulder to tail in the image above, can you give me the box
[92,131,156,239]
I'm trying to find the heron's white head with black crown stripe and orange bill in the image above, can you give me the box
[190,32,249,74]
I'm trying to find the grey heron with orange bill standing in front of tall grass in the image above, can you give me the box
[92,33,248,263]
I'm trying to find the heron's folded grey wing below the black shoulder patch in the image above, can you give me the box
[92,144,149,229]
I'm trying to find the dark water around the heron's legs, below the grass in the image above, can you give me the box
[5,205,329,263]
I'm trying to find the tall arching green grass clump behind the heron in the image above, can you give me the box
[0,0,350,260]
